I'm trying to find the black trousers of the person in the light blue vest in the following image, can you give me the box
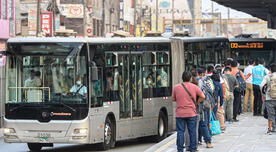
[253,84,263,115]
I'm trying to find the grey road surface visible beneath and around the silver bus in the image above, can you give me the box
[0,138,156,152]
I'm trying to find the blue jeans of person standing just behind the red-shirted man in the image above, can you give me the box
[198,110,212,143]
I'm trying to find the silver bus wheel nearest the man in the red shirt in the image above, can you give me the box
[155,111,168,142]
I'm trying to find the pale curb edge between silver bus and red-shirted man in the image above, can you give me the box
[144,132,176,152]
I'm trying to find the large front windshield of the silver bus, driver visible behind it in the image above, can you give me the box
[6,43,88,106]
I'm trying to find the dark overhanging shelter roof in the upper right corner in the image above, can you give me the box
[213,0,276,29]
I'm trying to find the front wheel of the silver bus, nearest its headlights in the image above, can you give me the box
[101,118,115,150]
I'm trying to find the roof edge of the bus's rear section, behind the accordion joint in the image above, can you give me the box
[171,37,229,42]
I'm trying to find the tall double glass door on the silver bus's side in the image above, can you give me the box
[118,53,143,118]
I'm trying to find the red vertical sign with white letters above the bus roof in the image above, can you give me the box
[41,12,53,36]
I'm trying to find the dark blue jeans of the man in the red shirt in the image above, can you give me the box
[176,116,197,152]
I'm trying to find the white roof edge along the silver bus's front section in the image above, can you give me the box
[8,37,170,44]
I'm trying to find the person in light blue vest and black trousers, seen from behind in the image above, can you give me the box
[252,59,269,116]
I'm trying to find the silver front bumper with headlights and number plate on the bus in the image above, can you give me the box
[4,119,89,144]
